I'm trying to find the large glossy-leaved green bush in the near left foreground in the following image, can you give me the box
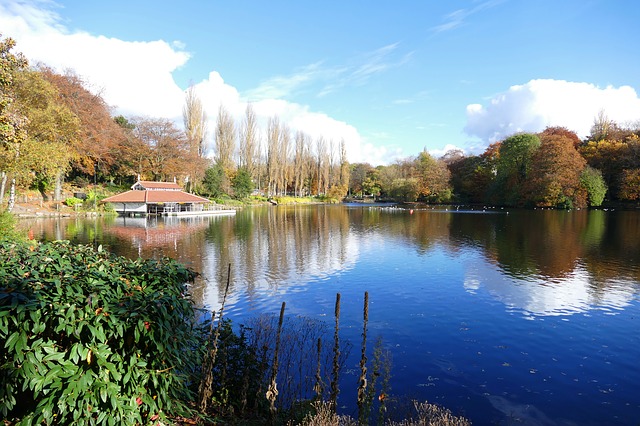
[0,242,203,425]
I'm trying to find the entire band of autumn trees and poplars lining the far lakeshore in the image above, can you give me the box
[0,35,640,210]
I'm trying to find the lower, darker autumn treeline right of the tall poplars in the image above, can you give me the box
[350,118,640,208]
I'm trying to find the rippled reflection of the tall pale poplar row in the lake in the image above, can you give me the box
[196,206,360,308]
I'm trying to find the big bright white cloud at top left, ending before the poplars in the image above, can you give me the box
[0,2,189,117]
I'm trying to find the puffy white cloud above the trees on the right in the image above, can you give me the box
[465,80,640,143]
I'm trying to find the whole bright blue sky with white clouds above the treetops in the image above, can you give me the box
[0,0,640,164]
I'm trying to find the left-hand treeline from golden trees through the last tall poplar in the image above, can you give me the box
[0,35,349,211]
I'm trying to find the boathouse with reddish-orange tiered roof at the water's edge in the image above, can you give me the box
[102,180,211,216]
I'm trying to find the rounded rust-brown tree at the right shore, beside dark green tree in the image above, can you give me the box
[524,133,587,208]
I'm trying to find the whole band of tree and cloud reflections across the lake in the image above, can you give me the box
[27,206,640,315]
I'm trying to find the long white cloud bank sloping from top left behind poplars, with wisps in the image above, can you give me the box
[0,0,395,164]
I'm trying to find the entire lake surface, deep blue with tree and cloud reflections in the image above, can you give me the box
[28,206,640,425]
